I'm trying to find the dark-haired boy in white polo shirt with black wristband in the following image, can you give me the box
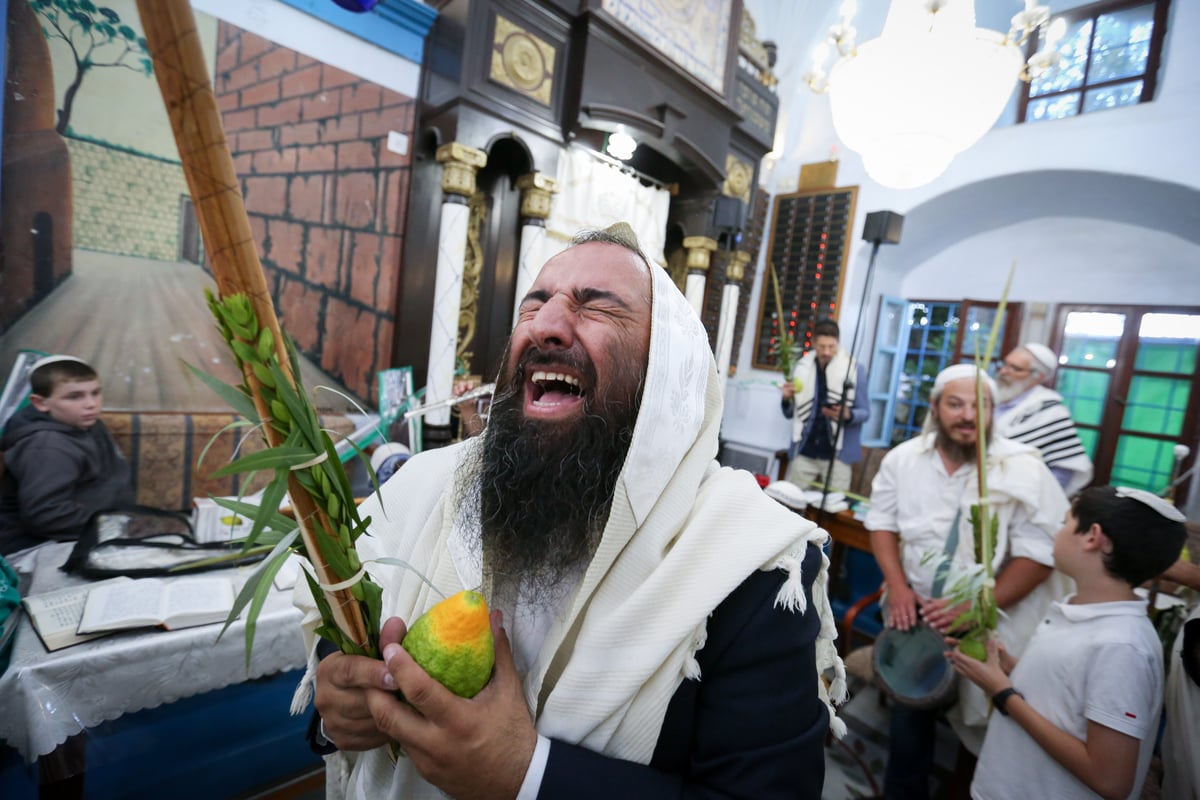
[947,486,1187,800]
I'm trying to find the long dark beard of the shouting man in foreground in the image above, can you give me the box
[463,348,642,597]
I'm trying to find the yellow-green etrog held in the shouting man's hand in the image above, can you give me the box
[400,590,496,697]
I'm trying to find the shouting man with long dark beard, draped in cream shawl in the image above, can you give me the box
[302,227,845,800]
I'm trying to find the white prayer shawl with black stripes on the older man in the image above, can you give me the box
[996,386,1092,497]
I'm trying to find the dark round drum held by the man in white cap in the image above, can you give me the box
[872,625,958,709]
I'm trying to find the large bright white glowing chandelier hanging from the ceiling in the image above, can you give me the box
[804,0,1066,188]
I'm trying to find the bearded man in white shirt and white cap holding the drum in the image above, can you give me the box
[864,365,1068,799]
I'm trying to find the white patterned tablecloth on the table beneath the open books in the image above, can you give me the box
[0,543,305,762]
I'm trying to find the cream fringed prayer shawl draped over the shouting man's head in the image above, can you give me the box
[296,257,845,800]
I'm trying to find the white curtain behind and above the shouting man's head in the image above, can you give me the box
[545,148,671,265]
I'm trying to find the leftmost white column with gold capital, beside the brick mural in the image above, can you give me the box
[425,142,487,426]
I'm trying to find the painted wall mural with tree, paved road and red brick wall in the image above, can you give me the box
[0,0,414,410]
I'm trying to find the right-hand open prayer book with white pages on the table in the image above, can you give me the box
[78,576,234,633]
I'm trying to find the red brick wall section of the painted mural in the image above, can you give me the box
[214,22,414,397]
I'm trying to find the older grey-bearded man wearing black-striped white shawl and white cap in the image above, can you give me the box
[996,342,1092,497]
